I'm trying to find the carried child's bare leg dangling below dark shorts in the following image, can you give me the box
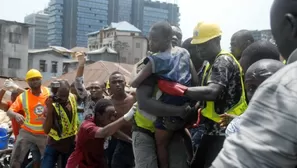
[155,129,172,168]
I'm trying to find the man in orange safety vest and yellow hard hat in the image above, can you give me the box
[7,69,50,168]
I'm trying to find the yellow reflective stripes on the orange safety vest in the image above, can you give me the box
[21,87,50,133]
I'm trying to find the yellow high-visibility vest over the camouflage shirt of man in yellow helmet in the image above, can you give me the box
[201,51,248,123]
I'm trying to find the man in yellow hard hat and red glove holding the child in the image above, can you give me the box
[159,22,247,167]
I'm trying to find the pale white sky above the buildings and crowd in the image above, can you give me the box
[0,0,273,49]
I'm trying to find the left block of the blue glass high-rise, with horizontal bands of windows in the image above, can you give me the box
[48,0,108,48]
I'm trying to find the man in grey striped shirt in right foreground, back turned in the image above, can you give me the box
[212,0,297,168]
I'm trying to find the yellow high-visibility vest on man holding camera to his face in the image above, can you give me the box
[48,93,79,141]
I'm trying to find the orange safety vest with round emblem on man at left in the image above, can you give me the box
[20,86,50,134]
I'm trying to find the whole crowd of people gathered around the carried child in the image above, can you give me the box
[0,0,297,168]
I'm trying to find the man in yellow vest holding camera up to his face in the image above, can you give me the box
[41,80,79,168]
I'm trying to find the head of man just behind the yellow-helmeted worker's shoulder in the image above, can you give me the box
[230,30,255,60]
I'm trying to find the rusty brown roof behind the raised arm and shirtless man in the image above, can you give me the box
[44,61,134,86]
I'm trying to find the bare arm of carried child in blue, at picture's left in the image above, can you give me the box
[130,61,153,88]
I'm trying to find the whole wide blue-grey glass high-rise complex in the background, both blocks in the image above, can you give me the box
[48,0,180,48]
